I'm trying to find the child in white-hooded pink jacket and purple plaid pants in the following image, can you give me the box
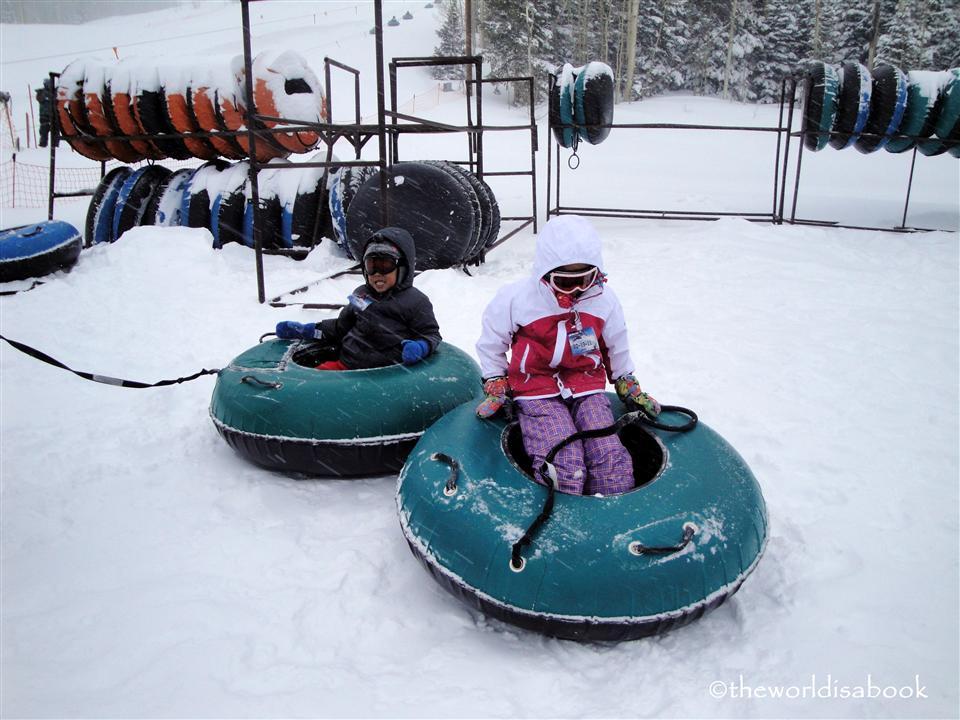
[477,215,660,495]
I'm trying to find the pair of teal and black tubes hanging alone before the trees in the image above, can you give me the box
[549,62,613,148]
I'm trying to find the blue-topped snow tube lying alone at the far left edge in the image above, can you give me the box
[0,220,83,282]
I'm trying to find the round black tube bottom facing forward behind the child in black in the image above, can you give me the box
[347,162,475,270]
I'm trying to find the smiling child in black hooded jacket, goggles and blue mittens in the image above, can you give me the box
[277,227,441,370]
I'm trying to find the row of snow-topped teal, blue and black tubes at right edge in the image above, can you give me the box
[797,61,960,157]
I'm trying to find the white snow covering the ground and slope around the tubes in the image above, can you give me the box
[0,3,960,718]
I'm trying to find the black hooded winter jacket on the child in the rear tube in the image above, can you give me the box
[318,228,441,370]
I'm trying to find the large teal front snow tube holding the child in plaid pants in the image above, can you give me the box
[397,394,767,641]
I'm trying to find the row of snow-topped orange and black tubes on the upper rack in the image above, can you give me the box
[56,51,326,163]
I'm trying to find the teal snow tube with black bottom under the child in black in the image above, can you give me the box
[210,340,480,477]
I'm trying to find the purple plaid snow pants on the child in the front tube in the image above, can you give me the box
[516,393,633,495]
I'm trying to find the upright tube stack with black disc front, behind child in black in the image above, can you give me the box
[329,161,500,270]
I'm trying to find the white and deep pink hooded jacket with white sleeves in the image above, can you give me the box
[477,215,634,399]
